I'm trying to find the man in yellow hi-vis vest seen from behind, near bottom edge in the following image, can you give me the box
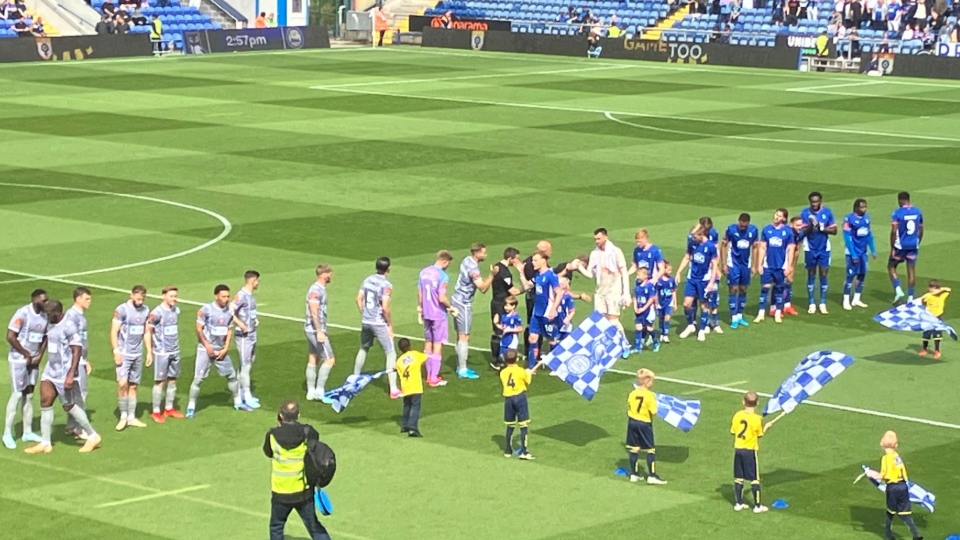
[263,401,330,540]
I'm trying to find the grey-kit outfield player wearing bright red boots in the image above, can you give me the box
[143,285,183,424]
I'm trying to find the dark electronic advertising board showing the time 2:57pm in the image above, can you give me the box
[183,26,330,54]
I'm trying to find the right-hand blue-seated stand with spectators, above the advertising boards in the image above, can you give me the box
[424,0,960,54]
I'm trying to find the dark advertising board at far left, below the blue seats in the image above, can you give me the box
[0,34,153,62]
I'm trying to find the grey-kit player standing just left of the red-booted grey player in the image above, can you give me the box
[110,285,150,431]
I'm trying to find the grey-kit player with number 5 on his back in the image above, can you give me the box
[353,257,403,399]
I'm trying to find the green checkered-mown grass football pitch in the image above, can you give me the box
[0,48,960,540]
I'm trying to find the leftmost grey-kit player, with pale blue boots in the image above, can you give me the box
[3,289,47,450]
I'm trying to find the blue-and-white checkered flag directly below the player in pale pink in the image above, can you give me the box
[542,311,630,400]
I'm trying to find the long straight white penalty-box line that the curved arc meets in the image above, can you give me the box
[310,88,960,143]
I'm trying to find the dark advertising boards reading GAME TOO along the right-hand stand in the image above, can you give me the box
[422,26,960,79]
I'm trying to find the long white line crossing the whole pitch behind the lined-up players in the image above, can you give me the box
[0,268,960,429]
